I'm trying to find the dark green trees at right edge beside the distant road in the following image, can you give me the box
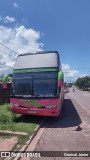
[75,76,90,89]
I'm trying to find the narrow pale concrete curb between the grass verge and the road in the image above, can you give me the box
[13,120,44,160]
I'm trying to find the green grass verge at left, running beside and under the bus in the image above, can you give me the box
[0,104,43,150]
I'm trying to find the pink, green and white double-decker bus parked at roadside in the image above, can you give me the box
[10,51,64,116]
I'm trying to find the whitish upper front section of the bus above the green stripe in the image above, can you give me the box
[14,51,61,69]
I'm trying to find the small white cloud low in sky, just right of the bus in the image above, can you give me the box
[62,64,86,82]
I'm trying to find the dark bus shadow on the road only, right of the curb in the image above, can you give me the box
[42,99,82,128]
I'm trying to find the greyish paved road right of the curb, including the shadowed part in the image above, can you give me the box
[20,88,90,160]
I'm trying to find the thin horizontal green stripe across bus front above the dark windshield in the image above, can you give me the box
[13,68,58,73]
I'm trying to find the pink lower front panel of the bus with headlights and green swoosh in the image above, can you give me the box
[10,98,62,116]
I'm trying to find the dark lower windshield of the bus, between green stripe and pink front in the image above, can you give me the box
[11,72,58,97]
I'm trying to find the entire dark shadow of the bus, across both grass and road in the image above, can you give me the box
[15,99,82,128]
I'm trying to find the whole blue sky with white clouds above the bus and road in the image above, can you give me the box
[0,0,90,82]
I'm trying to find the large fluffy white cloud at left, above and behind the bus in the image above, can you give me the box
[0,26,43,74]
